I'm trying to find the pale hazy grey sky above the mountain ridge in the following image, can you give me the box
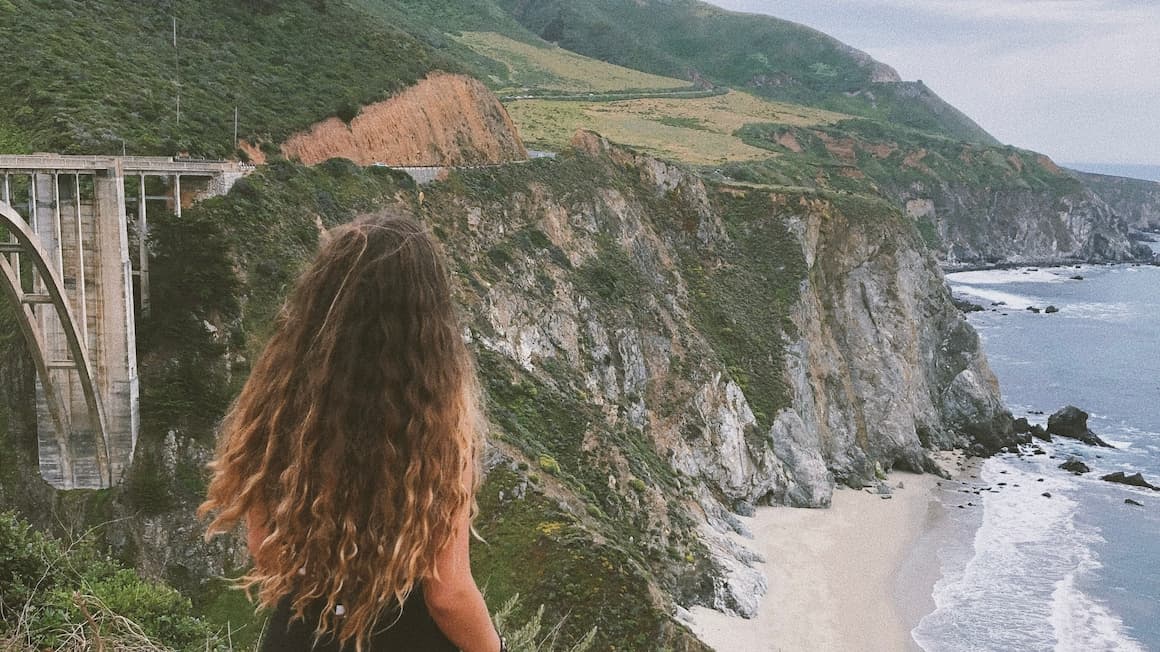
[709,0,1160,165]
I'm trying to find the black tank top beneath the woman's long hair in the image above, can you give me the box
[261,586,459,652]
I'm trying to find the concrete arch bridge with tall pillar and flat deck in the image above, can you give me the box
[0,154,253,490]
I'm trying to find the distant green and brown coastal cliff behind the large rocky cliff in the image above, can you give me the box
[734,121,1152,267]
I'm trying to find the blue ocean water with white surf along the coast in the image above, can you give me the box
[912,256,1160,652]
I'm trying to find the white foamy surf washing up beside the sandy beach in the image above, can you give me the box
[913,452,1139,652]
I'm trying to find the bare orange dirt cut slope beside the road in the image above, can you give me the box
[282,73,528,167]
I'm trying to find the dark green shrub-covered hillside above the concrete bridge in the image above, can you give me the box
[0,0,459,157]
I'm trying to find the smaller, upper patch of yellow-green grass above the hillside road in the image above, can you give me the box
[458,31,689,94]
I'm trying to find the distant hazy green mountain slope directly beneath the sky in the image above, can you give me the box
[496,0,995,143]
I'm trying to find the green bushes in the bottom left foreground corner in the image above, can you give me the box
[0,513,229,652]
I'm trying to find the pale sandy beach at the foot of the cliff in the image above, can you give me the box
[690,455,959,652]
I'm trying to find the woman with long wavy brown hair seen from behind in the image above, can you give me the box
[200,208,502,652]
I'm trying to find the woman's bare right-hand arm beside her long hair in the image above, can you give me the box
[423,496,500,652]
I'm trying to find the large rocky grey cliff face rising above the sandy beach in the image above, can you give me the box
[425,129,1010,614]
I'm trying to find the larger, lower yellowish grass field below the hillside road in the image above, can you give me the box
[506,90,849,165]
